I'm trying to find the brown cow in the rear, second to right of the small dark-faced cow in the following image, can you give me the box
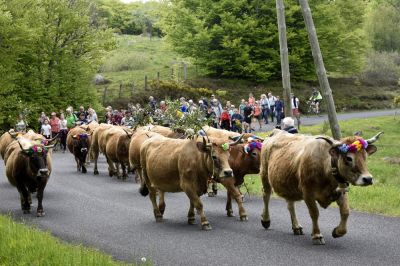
[105,128,133,180]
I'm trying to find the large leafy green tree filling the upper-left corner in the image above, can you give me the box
[0,0,114,128]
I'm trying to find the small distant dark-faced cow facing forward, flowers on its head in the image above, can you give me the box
[67,126,90,174]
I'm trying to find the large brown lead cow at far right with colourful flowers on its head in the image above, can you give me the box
[260,129,382,245]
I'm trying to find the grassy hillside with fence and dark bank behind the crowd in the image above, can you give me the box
[97,35,400,111]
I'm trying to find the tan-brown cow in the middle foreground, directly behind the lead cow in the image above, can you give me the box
[140,137,239,230]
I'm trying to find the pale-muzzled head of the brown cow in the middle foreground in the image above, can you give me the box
[197,137,241,179]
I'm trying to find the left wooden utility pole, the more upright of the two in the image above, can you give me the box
[276,0,292,117]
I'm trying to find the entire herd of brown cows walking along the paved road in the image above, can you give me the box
[0,122,382,245]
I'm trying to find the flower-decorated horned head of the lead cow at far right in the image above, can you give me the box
[330,132,383,186]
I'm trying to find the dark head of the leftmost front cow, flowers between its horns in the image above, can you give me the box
[18,140,55,180]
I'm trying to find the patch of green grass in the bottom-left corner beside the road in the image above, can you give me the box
[0,215,134,266]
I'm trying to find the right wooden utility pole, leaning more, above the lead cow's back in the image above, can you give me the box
[299,0,341,140]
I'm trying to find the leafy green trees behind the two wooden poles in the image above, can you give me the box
[161,0,366,81]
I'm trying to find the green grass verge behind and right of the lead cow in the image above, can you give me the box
[246,116,400,216]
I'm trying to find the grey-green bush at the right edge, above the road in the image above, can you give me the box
[361,52,400,86]
